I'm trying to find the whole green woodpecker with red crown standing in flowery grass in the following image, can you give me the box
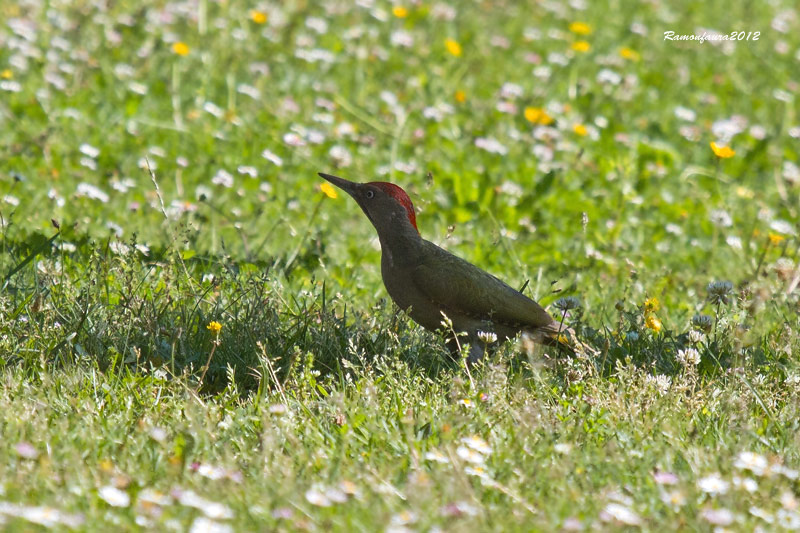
[319,172,574,364]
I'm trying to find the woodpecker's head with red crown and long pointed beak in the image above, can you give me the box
[319,172,419,235]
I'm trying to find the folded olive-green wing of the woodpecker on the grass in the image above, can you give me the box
[411,241,558,331]
